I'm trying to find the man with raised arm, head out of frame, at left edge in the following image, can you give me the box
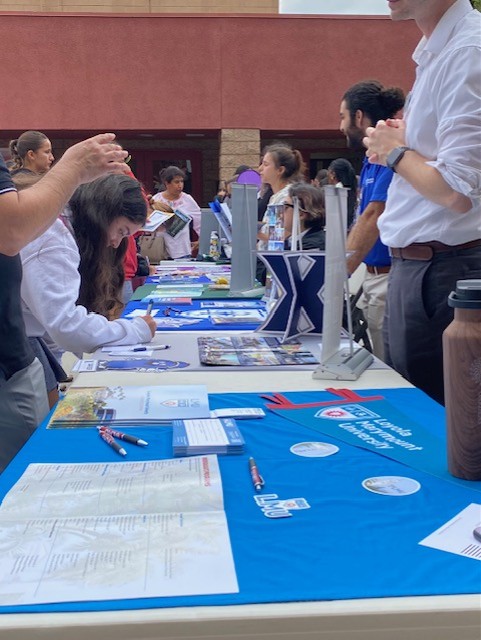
[0,133,127,473]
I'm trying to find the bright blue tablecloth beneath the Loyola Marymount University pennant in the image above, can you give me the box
[0,389,481,612]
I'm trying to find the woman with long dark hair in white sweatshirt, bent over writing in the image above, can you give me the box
[20,175,156,402]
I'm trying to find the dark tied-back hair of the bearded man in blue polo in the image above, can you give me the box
[342,80,404,126]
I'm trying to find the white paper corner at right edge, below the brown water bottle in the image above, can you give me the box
[419,503,481,560]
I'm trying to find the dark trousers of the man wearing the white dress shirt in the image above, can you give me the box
[384,247,481,404]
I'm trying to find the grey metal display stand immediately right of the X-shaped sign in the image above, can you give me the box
[312,185,374,380]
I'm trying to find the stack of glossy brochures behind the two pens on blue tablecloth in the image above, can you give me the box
[48,385,210,429]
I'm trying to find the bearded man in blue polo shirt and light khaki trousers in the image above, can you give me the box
[339,80,404,360]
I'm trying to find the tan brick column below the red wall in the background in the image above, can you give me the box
[219,129,261,180]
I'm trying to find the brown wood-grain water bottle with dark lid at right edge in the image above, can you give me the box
[443,280,481,480]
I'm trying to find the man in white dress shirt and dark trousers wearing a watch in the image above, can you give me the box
[364,0,481,402]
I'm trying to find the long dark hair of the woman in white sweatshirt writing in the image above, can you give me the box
[69,174,147,320]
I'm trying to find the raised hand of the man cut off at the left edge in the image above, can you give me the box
[57,133,128,184]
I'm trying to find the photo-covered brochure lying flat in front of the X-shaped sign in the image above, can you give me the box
[197,335,319,367]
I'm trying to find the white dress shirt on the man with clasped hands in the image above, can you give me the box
[378,0,481,247]
